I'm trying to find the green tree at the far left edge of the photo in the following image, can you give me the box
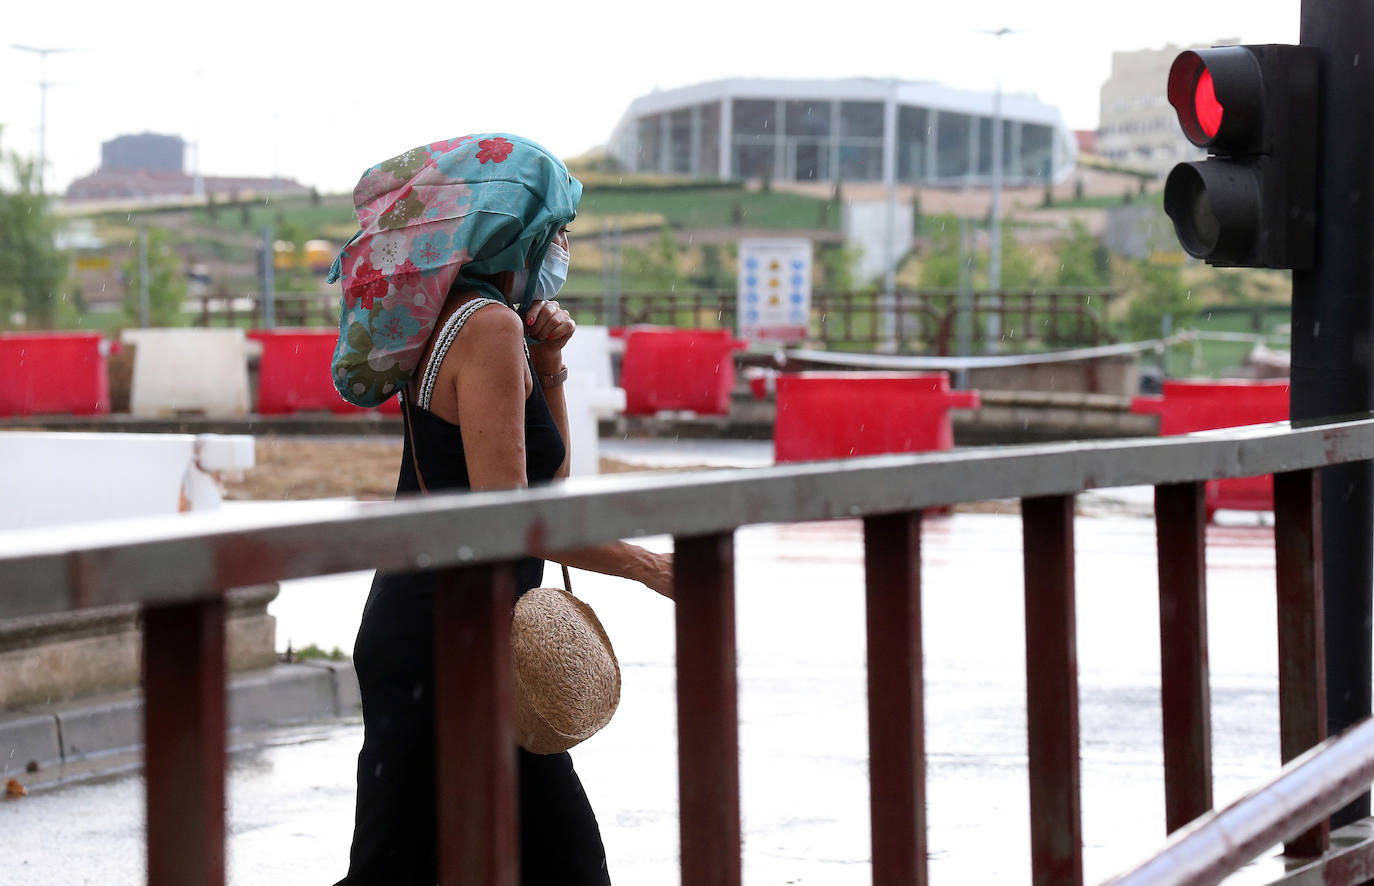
[0,146,67,328]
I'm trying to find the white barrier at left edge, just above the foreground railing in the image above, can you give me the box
[0,431,254,530]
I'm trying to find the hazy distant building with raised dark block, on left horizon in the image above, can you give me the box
[66,132,309,201]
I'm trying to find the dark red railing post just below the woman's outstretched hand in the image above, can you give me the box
[673,533,741,886]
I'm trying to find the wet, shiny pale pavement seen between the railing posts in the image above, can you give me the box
[0,439,1302,886]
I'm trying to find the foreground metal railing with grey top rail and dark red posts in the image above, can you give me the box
[0,419,1374,886]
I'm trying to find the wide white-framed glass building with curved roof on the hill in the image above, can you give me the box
[610,80,1077,187]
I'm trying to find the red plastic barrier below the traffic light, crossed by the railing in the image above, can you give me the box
[1131,379,1289,515]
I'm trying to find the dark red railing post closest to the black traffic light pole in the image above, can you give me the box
[1274,470,1330,857]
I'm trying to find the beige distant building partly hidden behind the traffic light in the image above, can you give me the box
[1096,40,1235,177]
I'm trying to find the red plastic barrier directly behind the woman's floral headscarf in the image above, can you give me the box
[249,330,401,415]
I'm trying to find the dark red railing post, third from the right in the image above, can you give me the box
[1021,496,1083,886]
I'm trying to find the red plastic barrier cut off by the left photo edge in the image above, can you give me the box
[0,332,110,415]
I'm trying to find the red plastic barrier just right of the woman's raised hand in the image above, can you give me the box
[620,328,742,415]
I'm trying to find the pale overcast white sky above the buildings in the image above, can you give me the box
[0,0,1300,192]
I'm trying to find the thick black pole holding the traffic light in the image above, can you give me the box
[1290,0,1374,827]
